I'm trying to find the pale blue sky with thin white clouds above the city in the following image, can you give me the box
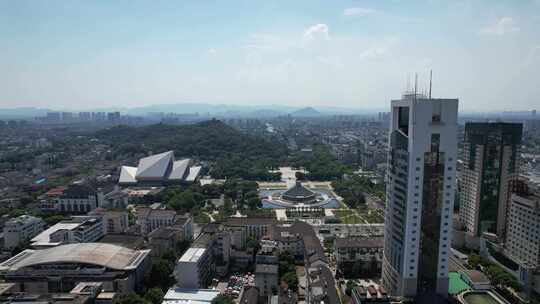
[0,0,540,111]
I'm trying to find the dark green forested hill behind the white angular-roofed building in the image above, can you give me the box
[96,120,287,180]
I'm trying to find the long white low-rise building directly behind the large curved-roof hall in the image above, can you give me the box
[30,216,105,249]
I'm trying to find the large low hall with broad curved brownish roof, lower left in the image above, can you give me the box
[0,243,150,294]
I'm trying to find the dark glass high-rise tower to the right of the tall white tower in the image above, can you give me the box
[459,122,523,239]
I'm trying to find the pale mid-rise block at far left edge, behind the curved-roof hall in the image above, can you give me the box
[4,215,45,250]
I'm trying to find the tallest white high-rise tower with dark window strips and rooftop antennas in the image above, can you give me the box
[382,93,458,297]
